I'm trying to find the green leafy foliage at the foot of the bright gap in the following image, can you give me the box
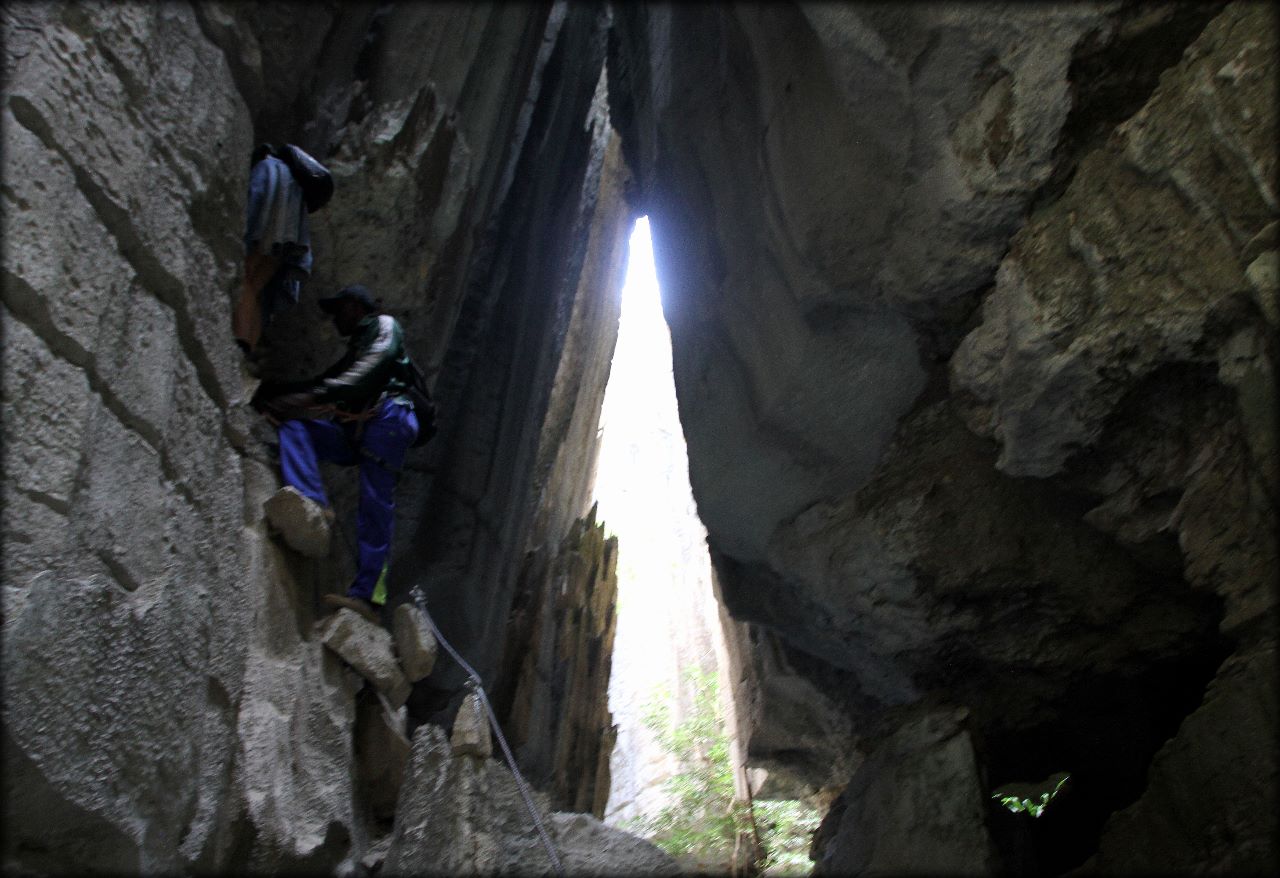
[626,668,819,875]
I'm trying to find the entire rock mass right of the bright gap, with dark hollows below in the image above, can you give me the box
[609,4,1280,873]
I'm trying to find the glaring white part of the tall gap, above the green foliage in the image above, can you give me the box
[595,218,719,823]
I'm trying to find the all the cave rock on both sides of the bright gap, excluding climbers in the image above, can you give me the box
[0,3,1280,873]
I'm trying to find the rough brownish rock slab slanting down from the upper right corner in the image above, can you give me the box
[952,1,1276,476]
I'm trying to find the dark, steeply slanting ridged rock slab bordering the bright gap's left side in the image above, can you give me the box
[393,4,630,747]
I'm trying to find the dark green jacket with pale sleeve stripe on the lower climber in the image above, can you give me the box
[312,314,410,412]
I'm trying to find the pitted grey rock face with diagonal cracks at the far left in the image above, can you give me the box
[3,4,262,872]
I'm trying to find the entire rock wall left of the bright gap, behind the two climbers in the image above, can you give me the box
[0,3,627,873]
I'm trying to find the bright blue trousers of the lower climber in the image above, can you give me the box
[279,399,417,600]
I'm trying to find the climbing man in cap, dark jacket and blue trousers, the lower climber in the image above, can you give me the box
[262,284,419,622]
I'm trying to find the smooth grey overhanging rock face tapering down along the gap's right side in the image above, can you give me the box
[611,4,1105,562]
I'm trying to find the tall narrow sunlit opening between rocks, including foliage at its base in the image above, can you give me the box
[595,218,817,874]
